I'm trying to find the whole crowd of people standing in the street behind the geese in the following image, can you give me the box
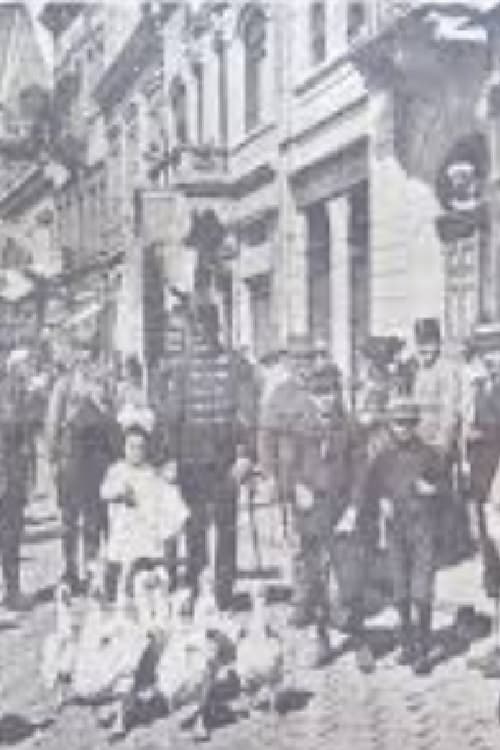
[0,303,500,736]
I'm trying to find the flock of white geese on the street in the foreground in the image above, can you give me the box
[41,568,285,740]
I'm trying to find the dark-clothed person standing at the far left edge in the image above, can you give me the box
[0,354,31,610]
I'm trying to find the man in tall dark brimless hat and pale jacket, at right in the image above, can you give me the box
[413,318,460,556]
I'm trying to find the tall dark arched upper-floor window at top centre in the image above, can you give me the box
[243,8,266,133]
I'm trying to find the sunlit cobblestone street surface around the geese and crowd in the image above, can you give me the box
[0,494,500,750]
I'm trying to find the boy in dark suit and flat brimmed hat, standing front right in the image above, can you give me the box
[367,397,445,674]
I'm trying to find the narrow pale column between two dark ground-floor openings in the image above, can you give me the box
[328,195,352,384]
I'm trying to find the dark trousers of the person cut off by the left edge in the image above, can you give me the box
[0,495,24,597]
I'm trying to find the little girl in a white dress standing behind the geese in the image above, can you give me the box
[101,417,189,608]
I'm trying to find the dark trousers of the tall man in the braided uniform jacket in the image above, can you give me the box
[179,463,237,606]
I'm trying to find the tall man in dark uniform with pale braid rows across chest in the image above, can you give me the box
[168,302,256,609]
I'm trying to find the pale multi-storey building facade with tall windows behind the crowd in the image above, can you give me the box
[1,0,500,400]
